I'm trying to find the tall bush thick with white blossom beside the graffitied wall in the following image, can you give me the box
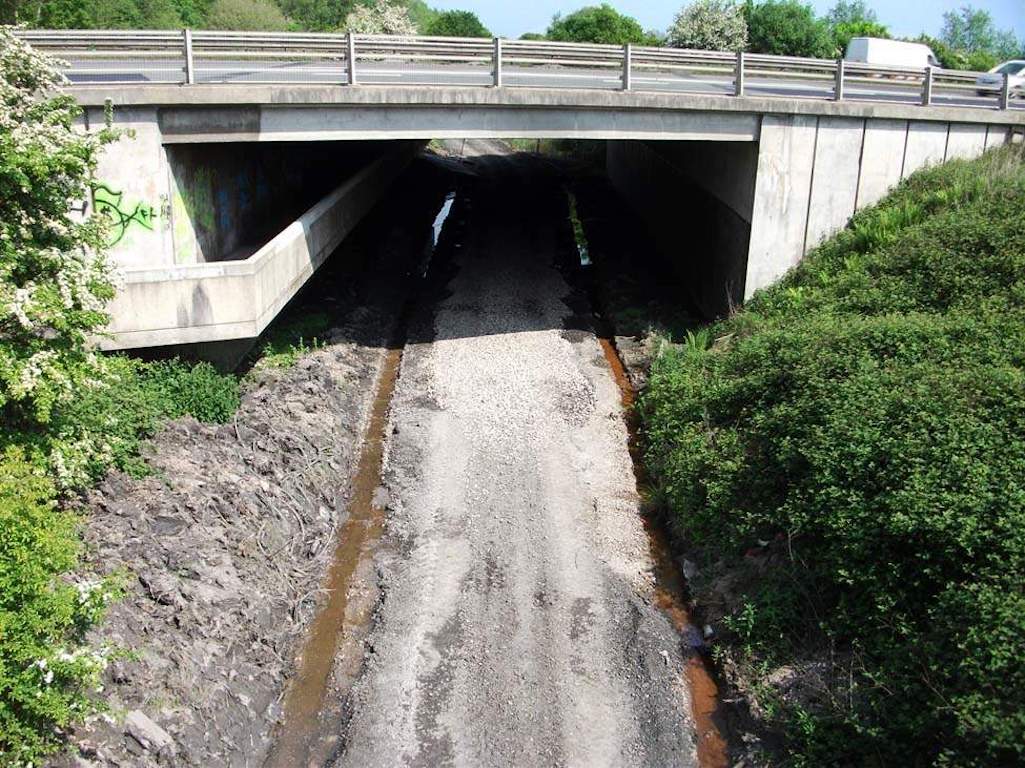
[0,27,116,423]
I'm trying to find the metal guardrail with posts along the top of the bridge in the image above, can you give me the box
[17,30,1014,110]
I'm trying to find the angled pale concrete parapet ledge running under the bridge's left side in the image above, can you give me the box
[100,142,421,350]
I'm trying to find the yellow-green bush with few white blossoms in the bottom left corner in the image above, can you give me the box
[0,449,118,766]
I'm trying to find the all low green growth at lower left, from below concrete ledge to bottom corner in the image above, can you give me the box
[0,357,239,766]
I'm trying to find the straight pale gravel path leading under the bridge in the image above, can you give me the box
[335,153,696,767]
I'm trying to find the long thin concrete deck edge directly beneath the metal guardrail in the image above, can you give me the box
[68,84,1025,127]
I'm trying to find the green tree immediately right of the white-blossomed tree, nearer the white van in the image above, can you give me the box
[745,0,836,58]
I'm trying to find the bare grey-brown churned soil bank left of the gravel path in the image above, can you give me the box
[58,158,443,767]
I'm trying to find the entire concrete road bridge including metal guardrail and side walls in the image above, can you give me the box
[22,31,1025,349]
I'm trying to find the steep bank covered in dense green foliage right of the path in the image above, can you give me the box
[640,148,1025,765]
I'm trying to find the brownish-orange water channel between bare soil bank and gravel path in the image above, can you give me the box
[264,347,402,768]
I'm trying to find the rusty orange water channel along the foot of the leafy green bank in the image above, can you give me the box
[599,334,729,768]
